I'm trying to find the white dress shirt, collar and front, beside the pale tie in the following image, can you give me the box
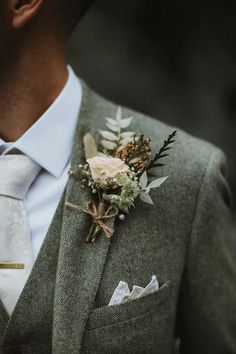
[0,66,82,259]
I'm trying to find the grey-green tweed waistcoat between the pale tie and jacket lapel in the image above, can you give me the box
[0,189,65,354]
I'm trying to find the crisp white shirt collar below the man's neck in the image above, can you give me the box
[0,66,82,178]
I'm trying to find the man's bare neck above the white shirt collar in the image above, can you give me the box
[0,50,68,142]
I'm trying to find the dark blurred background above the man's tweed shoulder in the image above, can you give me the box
[69,0,236,233]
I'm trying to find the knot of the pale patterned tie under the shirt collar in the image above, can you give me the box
[0,155,41,200]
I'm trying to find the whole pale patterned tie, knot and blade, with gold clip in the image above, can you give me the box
[0,155,41,315]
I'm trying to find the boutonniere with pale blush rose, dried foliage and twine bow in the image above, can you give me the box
[66,107,177,242]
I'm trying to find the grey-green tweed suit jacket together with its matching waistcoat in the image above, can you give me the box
[0,79,236,354]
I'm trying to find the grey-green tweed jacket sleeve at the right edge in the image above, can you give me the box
[176,149,236,354]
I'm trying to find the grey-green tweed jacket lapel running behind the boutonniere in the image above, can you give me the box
[53,83,114,354]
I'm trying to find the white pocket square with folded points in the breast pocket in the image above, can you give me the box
[108,275,159,306]
